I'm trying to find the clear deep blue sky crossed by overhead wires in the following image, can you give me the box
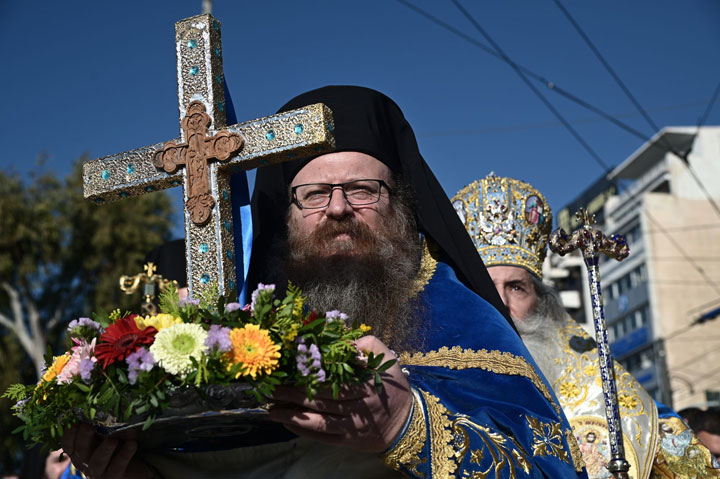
[0,0,720,237]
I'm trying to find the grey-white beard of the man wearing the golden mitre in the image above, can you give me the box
[512,276,567,382]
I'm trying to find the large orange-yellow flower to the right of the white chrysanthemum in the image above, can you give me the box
[227,324,280,379]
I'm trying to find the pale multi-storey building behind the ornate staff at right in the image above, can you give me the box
[547,127,720,409]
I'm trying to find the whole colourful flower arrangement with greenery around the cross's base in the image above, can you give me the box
[3,284,395,448]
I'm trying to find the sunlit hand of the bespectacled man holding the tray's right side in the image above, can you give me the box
[270,336,412,453]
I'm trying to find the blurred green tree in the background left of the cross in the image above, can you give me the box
[0,158,172,470]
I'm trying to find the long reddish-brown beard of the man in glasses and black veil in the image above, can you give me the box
[285,207,424,352]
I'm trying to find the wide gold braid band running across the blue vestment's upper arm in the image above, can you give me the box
[399,346,562,416]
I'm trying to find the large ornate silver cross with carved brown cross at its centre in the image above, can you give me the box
[83,14,335,294]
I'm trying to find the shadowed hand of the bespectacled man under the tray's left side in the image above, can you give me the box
[61,424,152,479]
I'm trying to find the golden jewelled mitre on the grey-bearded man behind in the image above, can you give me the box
[452,173,552,278]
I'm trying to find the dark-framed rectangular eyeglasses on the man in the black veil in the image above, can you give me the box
[290,180,392,209]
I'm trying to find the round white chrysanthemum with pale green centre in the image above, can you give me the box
[150,323,207,376]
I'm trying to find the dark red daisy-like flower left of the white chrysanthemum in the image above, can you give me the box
[95,314,157,369]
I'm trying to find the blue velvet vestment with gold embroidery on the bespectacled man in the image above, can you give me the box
[383,254,587,479]
